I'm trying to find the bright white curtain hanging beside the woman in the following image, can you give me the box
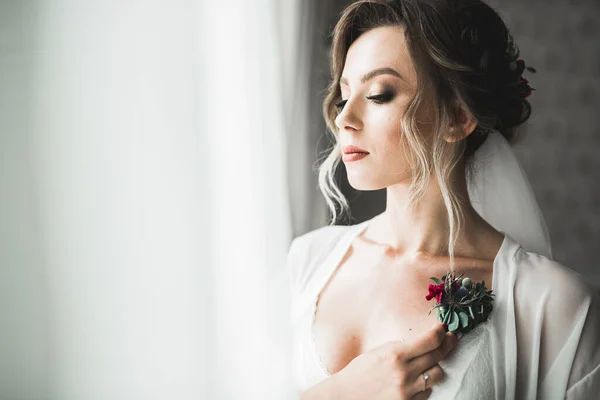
[0,0,308,400]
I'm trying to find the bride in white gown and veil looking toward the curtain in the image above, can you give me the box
[288,0,600,400]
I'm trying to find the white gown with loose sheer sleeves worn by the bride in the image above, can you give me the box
[287,221,600,400]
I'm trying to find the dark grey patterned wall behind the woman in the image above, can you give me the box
[309,0,600,287]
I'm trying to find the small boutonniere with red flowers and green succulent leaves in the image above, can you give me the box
[425,272,494,333]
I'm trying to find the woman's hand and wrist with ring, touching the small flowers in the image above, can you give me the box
[302,324,458,400]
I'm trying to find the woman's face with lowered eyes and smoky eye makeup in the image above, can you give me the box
[335,27,426,190]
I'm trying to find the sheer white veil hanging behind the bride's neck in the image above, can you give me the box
[468,131,552,258]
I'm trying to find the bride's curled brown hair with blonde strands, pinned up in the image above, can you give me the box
[319,0,531,268]
